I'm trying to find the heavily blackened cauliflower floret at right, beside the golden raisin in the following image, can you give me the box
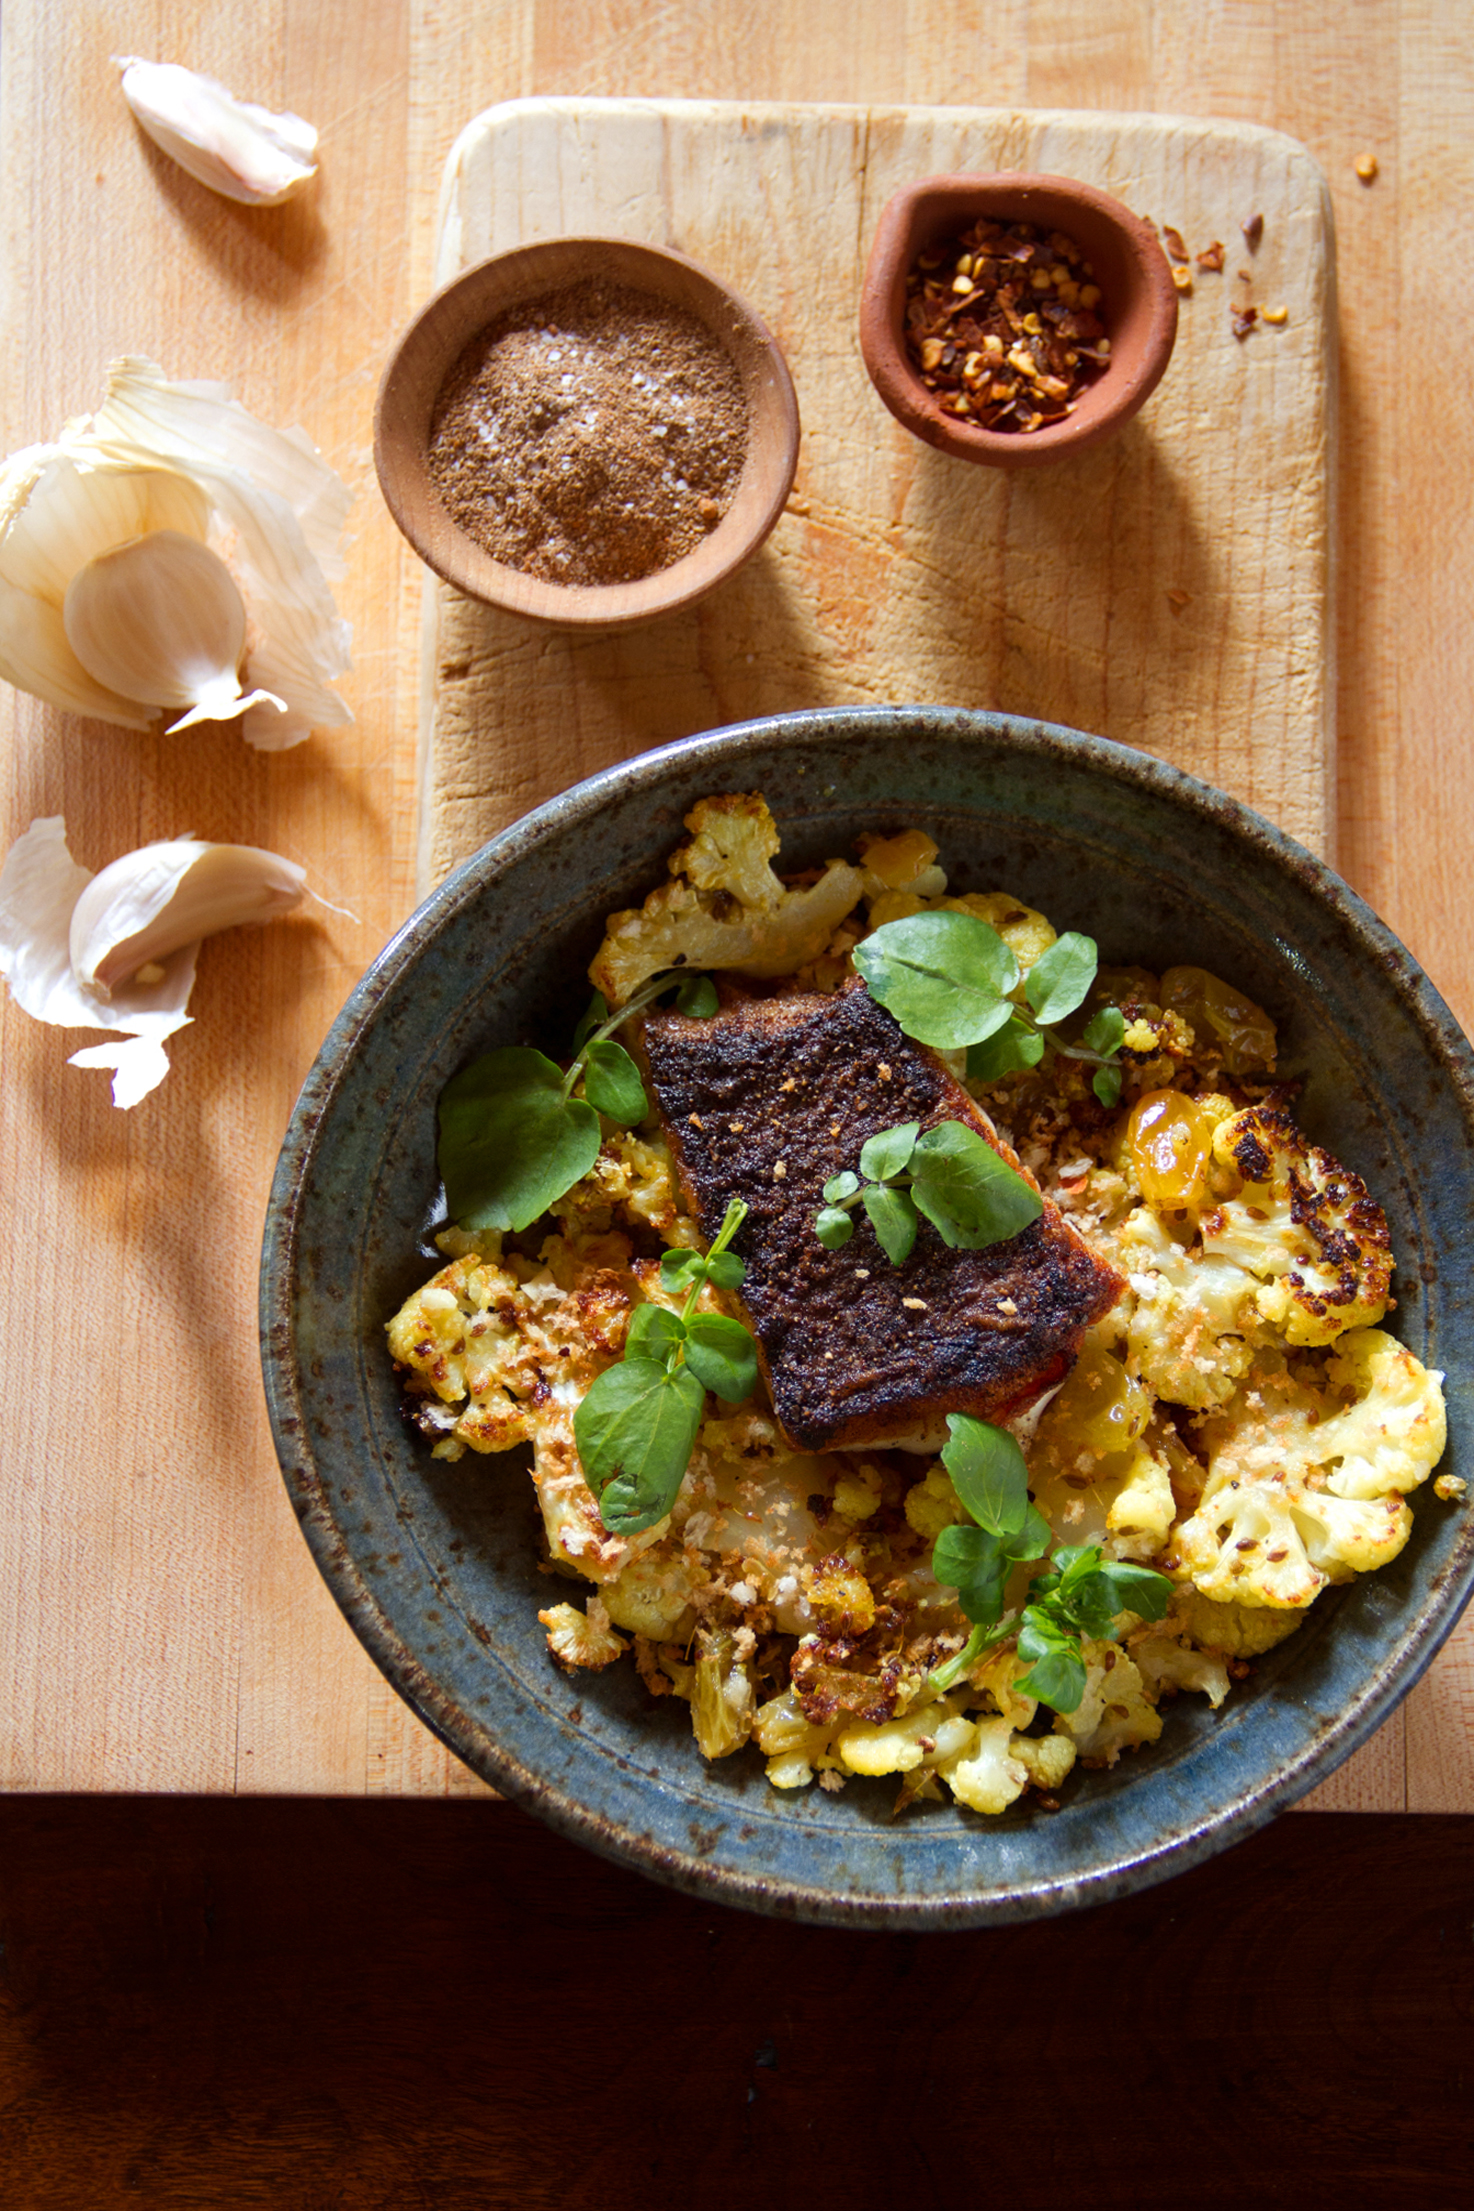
[1202,1103,1392,1344]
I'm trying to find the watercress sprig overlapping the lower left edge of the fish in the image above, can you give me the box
[572,1198,758,1534]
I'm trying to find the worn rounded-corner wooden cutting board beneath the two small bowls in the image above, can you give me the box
[418,99,1335,889]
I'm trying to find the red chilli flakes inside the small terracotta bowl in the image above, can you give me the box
[906,219,1112,431]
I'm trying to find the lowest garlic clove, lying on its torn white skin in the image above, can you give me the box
[69,838,307,997]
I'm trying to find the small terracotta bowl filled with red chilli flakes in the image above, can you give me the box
[860,175,1178,469]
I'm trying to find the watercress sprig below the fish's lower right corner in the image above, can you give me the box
[930,1413,1171,1711]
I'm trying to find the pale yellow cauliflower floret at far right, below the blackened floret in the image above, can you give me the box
[1173,1329,1443,1612]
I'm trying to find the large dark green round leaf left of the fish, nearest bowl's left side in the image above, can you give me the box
[440,1044,599,1229]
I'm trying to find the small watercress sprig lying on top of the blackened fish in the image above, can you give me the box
[813,1121,1043,1267]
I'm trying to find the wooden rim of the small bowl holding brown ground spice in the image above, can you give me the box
[373,232,800,630]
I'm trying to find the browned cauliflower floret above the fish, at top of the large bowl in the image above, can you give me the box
[588,794,864,1006]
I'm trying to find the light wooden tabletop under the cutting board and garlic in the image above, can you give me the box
[0,0,1474,1811]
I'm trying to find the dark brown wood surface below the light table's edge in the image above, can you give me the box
[0,1798,1474,2211]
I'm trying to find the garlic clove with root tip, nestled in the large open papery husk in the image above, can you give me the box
[62,531,287,736]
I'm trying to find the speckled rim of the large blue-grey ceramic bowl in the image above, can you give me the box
[261,705,1474,1930]
